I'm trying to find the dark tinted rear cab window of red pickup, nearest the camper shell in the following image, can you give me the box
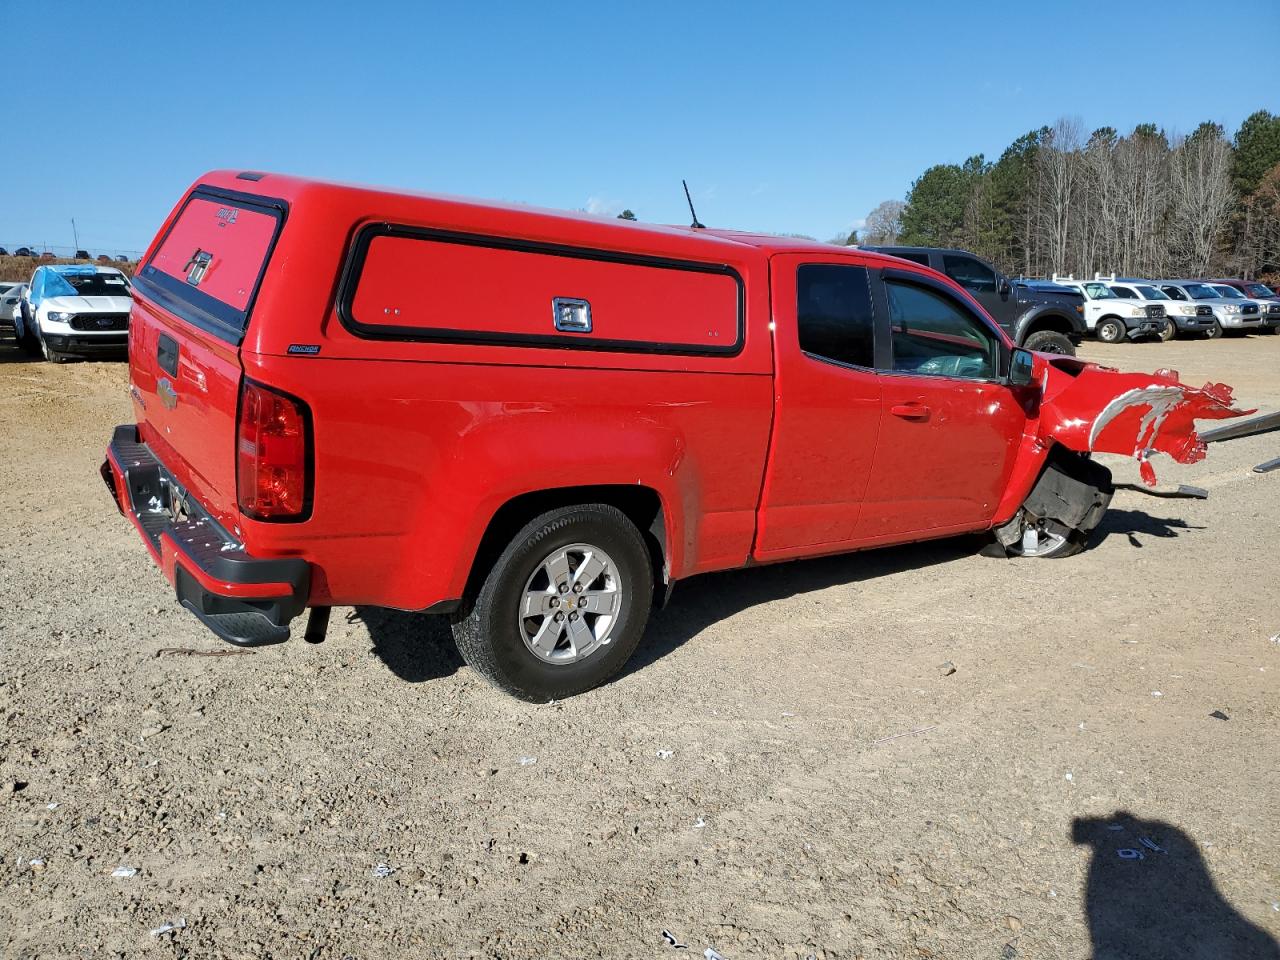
[796,264,876,367]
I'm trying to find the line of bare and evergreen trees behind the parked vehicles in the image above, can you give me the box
[847,110,1280,278]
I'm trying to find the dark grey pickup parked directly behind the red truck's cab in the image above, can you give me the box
[861,247,1088,356]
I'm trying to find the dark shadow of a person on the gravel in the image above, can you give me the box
[1071,810,1280,960]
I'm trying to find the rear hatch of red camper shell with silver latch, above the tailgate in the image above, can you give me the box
[134,188,285,343]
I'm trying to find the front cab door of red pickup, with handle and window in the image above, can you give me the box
[856,270,1030,545]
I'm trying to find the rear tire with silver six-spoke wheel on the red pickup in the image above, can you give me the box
[453,503,653,703]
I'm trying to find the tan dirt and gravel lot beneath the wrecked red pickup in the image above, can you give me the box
[0,337,1280,960]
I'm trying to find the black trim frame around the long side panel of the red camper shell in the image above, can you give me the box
[338,221,746,357]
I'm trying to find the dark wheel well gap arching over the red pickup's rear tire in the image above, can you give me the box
[466,484,671,609]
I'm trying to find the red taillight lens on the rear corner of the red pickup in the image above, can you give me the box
[236,381,308,520]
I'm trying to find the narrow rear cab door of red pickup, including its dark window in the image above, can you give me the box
[753,253,883,559]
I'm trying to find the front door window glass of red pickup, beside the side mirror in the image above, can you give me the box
[884,280,1000,380]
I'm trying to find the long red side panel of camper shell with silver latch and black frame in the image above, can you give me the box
[339,224,744,355]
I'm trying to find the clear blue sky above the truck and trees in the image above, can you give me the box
[0,0,1280,252]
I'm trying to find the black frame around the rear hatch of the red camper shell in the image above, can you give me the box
[133,183,289,347]
